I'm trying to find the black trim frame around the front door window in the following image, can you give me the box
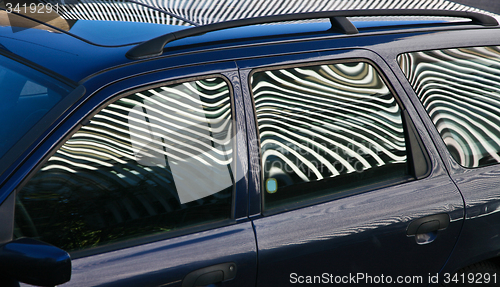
[11,73,238,259]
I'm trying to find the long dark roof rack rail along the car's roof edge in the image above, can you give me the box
[126,9,498,60]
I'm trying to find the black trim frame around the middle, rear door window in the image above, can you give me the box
[247,57,431,216]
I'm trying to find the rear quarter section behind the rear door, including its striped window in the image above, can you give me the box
[393,44,500,276]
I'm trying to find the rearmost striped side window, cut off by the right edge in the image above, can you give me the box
[398,47,500,168]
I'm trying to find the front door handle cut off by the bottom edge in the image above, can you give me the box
[182,262,236,287]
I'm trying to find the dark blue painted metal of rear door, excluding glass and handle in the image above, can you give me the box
[238,51,464,286]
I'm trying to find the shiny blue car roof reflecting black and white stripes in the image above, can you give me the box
[0,0,498,82]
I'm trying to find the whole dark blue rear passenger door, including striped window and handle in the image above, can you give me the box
[238,50,464,286]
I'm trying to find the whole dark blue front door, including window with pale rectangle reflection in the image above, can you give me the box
[3,62,256,286]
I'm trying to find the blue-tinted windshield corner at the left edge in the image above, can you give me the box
[0,55,72,158]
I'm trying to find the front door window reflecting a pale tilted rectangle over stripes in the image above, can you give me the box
[14,77,234,251]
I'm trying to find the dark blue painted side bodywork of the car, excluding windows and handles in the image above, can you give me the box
[0,16,500,286]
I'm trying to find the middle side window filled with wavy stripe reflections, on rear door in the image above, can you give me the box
[251,61,409,213]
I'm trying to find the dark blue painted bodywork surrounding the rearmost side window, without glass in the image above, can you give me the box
[376,27,500,273]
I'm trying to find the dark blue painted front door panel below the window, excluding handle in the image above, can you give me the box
[63,225,257,286]
